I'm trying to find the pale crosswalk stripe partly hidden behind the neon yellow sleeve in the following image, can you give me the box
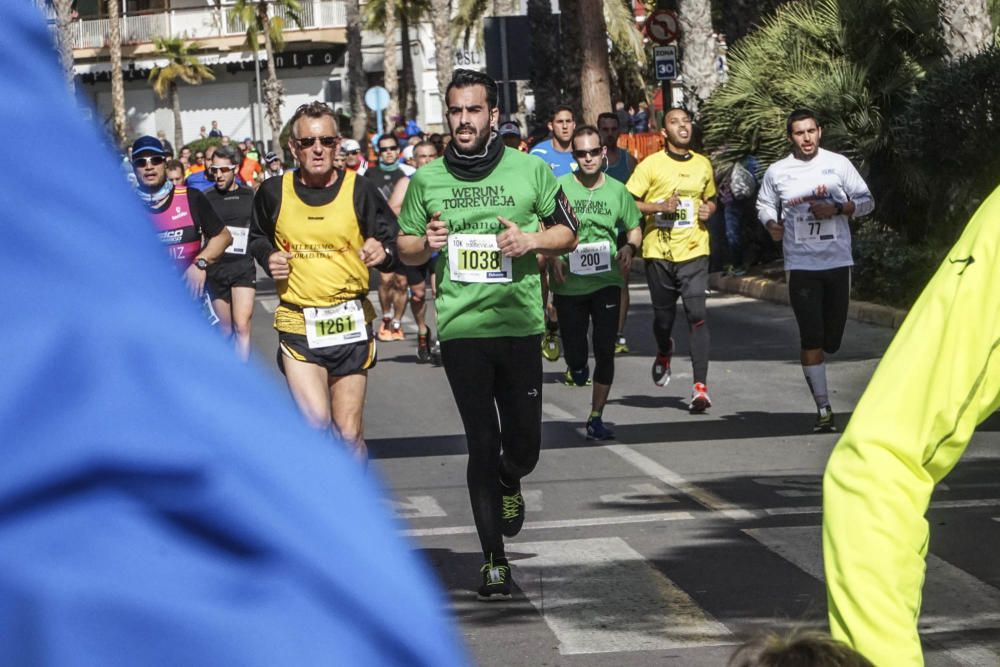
[743,526,1000,667]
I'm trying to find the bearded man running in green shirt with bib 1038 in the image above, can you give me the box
[398,69,577,601]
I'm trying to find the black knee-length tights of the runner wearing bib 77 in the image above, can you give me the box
[788,266,851,354]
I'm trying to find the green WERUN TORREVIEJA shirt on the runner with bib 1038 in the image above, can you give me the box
[399,148,559,341]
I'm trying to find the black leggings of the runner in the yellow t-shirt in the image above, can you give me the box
[645,257,709,383]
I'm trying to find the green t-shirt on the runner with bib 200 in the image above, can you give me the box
[549,174,642,296]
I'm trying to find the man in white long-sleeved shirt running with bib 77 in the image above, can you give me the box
[757,109,875,432]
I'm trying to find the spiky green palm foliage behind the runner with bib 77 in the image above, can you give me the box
[701,0,944,237]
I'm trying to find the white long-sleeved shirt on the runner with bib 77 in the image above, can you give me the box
[757,148,875,271]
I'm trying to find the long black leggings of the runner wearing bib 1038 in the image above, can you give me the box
[441,334,542,560]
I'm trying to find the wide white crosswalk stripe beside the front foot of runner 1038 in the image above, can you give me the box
[507,537,733,655]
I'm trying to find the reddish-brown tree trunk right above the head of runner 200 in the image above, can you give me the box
[577,0,611,125]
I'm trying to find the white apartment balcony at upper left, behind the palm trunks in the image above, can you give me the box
[60,0,347,49]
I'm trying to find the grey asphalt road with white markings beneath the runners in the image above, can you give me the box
[244,272,1000,667]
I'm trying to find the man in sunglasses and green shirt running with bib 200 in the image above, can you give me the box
[549,125,642,440]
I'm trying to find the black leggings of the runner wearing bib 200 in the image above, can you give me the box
[552,285,622,384]
